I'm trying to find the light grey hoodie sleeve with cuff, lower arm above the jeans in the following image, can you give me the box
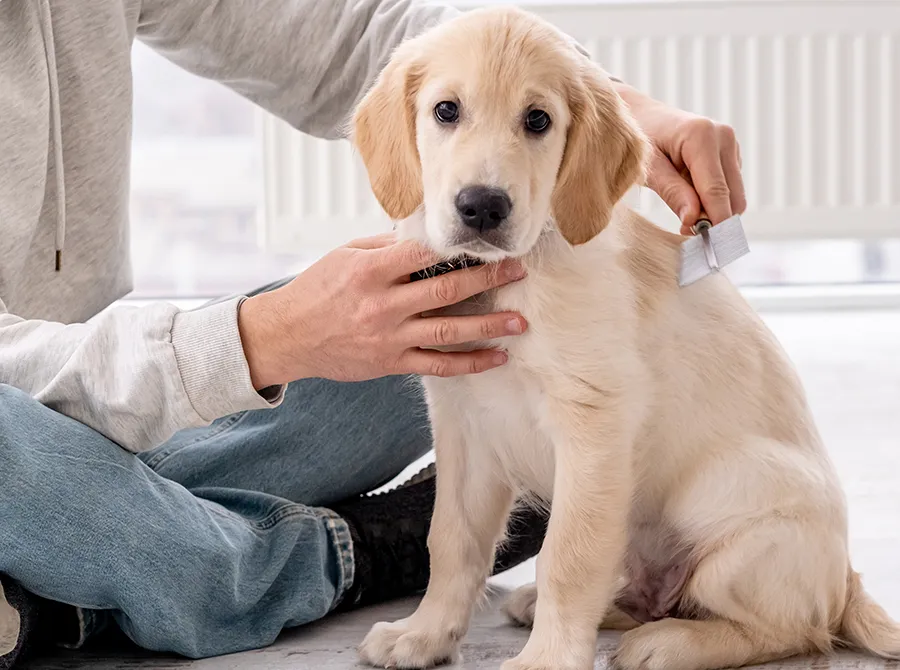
[0,298,283,452]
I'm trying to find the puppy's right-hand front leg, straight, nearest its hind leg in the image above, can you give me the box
[503,403,632,670]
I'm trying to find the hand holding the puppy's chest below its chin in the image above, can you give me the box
[238,234,527,389]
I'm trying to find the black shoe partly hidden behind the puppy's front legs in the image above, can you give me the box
[332,465,548,610]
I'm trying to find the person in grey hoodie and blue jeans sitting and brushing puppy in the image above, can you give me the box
[0,0,744,667]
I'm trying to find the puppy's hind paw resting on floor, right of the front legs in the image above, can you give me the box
[611,620,696,670]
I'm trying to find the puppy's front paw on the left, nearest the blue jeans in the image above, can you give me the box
[359,618,462,668]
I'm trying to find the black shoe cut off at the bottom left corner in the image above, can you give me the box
[0,575,80,670]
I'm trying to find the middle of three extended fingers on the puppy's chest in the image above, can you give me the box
[401,312,528,347]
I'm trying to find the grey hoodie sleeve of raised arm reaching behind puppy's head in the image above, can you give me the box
[137,0,459,139]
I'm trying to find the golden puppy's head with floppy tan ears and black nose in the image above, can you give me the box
[355,9,646,261]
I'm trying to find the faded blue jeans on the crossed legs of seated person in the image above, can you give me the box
[0,370,431,658]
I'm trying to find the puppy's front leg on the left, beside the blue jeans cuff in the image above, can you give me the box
[360,407,513,668]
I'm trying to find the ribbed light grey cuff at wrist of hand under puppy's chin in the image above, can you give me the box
[172,297,285,423]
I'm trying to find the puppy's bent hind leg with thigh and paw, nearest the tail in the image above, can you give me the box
[613,519,847,670]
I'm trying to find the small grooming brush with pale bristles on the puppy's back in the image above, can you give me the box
[678,214,750,286]
